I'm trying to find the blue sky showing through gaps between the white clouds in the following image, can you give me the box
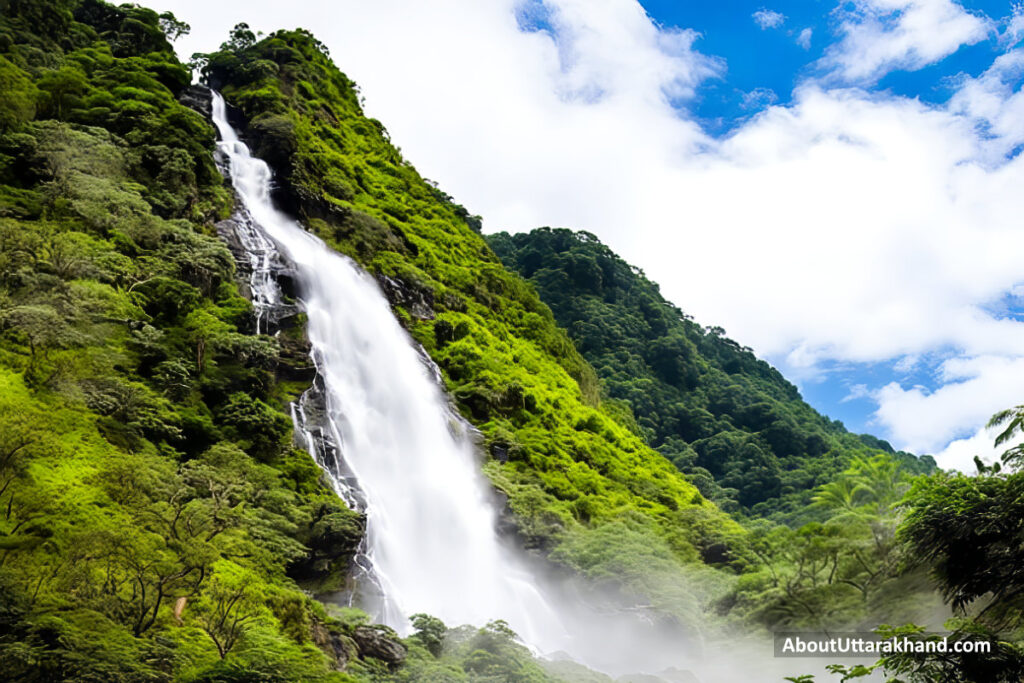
[642,0,1024,444]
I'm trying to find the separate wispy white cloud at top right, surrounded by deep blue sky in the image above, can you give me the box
[821,0,993,82]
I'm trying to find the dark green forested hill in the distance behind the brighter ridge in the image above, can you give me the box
[487,228,935,515]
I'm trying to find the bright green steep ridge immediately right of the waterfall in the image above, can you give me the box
[203,26,739,579]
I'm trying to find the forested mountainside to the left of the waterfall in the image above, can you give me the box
[0,0,376,681]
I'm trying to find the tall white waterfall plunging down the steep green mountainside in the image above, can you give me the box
[213,93,567,651]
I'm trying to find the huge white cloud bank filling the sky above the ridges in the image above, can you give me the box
[156,0,1024,457]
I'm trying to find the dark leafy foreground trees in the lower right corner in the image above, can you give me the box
[790,413,1024,683]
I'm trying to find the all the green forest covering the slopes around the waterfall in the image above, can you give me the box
[0,0,1024,682]
